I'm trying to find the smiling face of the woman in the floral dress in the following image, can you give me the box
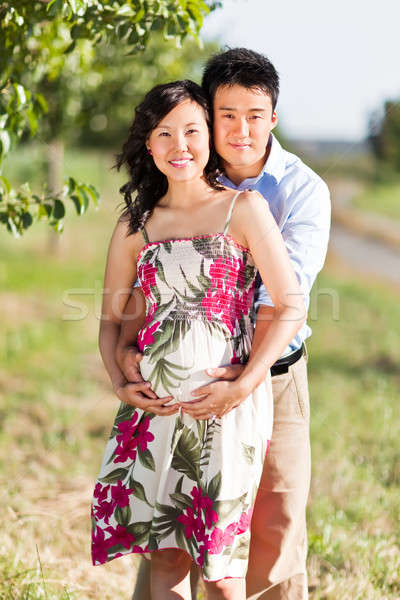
[146,99,210,182]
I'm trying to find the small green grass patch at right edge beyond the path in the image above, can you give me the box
[353,182,400,221]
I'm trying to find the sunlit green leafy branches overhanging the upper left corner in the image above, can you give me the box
[0,0,220,236]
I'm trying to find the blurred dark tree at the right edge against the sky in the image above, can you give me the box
[369,100,400,171]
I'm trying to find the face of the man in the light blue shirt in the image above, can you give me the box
[214,85,277,179]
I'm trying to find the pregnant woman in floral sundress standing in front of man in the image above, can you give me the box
[92,81,305,600]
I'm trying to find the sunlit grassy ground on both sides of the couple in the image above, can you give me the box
[0,148,400,600]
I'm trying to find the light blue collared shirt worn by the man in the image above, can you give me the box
[220,134,331,356]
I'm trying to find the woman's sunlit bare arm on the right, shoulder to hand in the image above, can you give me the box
[181,192,306,419]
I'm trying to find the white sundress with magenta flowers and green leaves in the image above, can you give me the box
[92,196,273,581]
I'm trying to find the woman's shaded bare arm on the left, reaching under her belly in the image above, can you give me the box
[99,220,177,414]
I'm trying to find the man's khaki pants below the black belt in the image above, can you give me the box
[133,356,311,600]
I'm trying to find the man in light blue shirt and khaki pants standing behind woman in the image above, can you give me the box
[117,48,330,600]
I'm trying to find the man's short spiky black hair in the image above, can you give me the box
[201,48,279,109]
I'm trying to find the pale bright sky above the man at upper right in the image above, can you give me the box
[202,0,400,141]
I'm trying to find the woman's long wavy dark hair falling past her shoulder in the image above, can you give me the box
[115,80,223,234]
